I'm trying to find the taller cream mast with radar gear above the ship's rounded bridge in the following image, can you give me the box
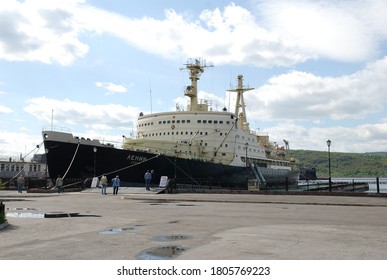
[180,59,213,111]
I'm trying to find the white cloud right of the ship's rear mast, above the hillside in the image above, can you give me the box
[245,57,387,121]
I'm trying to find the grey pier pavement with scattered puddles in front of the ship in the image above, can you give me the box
[0,188,387,260]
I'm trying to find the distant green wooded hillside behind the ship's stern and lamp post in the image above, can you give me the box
[287,150,387,177]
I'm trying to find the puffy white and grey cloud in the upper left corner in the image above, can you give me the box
[0,0,88,65]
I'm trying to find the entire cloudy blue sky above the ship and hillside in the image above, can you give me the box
[0,0,387,158]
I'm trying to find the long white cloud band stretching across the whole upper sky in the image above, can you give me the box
[0,0,387,67]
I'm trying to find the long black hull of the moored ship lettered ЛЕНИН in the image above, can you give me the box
[44,140,298,189]
